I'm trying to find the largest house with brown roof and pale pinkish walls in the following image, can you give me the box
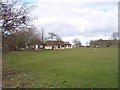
[45,40,64,49]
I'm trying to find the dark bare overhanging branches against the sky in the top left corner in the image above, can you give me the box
[0,0,31,35]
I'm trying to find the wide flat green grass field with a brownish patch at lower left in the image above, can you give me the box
[3,48,118,88]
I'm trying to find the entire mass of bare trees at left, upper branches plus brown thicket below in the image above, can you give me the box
[0,0,43,51]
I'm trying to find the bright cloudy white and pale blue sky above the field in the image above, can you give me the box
[25,0,119,45]
